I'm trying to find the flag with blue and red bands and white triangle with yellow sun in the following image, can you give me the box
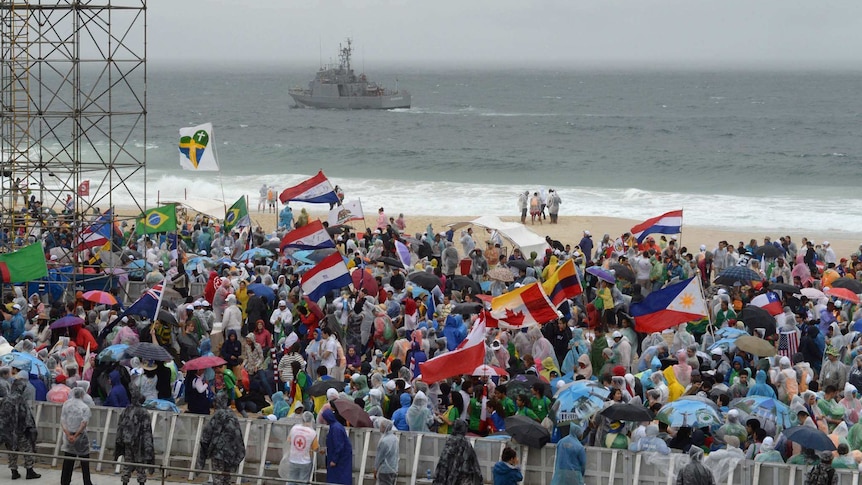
[629,277,708,333]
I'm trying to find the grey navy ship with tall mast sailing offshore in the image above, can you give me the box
[288,39,410,109]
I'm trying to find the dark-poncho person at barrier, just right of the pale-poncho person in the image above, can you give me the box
[114,389,156,485]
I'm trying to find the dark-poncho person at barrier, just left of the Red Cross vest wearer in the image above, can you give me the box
[197,392,245,485]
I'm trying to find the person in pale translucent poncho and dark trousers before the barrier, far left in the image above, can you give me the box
[60,387,93,485]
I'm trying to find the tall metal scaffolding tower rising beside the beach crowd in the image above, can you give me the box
[0,0,147,294]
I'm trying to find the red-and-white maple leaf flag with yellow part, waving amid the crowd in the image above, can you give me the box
[486,283,560,329]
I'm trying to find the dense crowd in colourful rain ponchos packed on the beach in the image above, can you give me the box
[5,199,862,484]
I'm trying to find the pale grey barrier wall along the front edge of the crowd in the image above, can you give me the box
[28,403,859,485]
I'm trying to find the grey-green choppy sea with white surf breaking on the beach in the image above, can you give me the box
[111,65,862,235]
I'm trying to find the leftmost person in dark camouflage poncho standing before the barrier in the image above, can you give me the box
[0,379,42,480]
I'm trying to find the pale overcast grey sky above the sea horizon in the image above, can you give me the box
[148,0,862,69]
